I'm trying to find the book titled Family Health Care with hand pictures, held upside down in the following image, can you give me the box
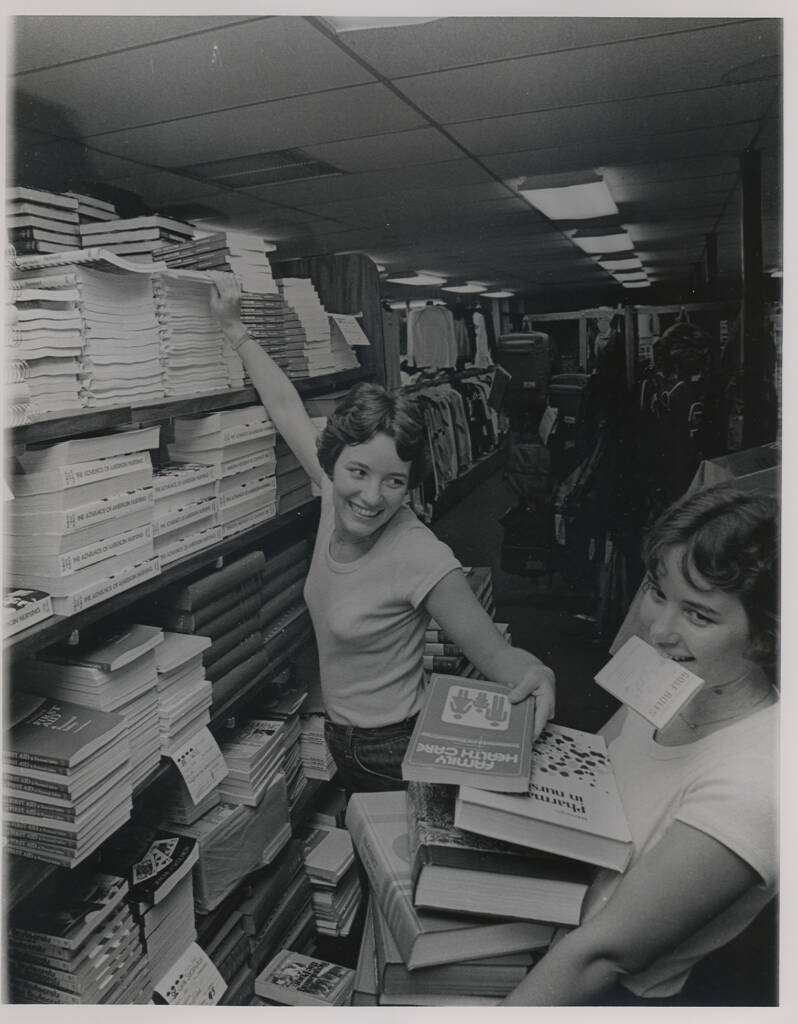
[402,673,535,793]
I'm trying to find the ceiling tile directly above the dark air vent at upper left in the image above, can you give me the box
[82,85,420,167]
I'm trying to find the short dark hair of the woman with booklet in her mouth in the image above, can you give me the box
[643,483,779,663]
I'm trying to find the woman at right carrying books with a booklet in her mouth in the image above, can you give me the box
[505,484,779,1006]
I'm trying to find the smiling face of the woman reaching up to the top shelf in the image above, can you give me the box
[333,434,411,543]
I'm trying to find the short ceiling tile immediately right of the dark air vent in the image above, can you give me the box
[304,128,463,173]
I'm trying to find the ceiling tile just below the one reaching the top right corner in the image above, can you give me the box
[446,82,776,156]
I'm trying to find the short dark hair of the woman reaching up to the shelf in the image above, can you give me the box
[319,384,427,487]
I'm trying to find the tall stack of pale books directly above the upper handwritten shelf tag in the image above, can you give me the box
[156,632,213,757]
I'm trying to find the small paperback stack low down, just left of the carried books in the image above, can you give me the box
[296,825,363,937]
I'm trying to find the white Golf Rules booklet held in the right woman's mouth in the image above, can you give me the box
[595,636,704,729]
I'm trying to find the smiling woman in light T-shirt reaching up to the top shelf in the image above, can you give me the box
[211,273,554,792]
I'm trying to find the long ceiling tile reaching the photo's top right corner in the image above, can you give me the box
[400,18,781,124]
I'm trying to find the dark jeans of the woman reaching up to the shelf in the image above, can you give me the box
[324,715,417,793]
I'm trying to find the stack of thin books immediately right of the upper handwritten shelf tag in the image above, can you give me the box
[217,719,285,807]
